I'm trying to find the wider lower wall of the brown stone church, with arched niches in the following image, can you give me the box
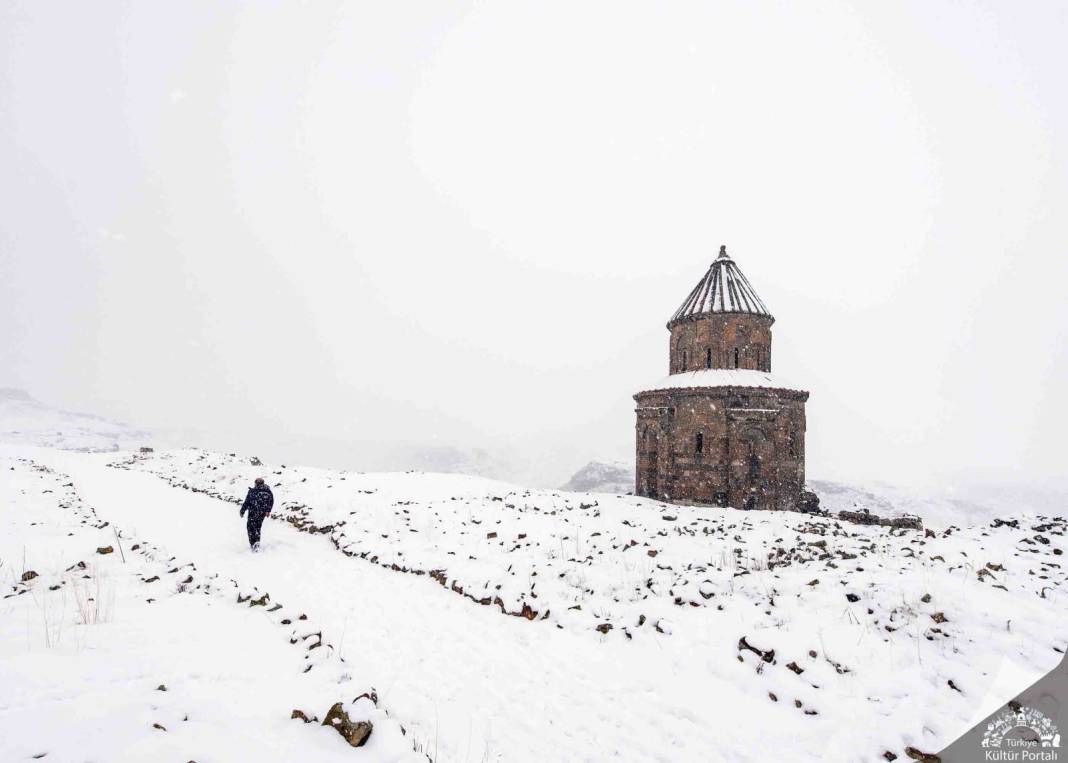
[634,387,808,509]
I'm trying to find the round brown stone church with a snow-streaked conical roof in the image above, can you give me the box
[634,247,808,510]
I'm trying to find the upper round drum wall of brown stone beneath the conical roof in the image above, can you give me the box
[668,313,774,374]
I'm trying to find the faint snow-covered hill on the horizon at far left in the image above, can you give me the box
[0,389,151,451]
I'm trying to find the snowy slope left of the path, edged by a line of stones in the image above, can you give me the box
[0,457,426,763]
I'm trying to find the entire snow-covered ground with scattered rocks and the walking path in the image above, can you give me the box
[0,448,1068,761]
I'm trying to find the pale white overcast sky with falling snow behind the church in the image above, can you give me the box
[0,0,1068,482]
